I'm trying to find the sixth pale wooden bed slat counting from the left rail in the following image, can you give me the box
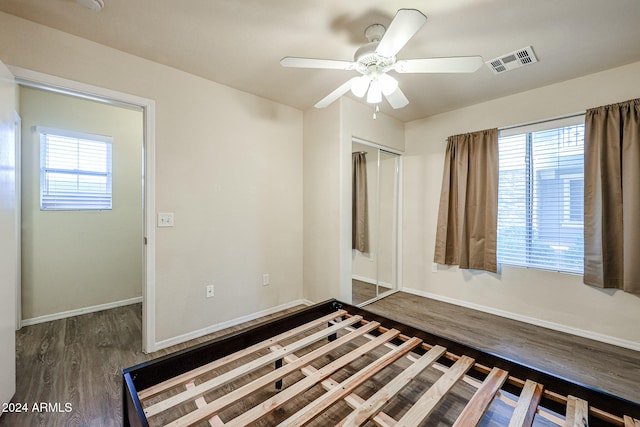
[336,345,447,427]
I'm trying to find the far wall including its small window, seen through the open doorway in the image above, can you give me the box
[18,85,143,325]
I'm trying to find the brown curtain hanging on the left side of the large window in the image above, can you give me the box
[434,129,498,272]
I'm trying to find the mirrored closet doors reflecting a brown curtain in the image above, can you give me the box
[351,140,401,305]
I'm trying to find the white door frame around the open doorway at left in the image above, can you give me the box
[7,65,156,353]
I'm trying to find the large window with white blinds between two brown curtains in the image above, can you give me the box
[498,116,584,274]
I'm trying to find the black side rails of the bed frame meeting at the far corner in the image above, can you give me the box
[122,300,640,427]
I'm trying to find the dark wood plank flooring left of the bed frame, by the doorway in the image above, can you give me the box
[0,304,302,427]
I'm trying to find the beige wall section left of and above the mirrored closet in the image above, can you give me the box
[304,97,404,302]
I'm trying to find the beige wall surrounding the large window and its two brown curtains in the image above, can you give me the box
[403,63,640,349]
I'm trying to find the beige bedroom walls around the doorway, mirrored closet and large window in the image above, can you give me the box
[5,9,640,352]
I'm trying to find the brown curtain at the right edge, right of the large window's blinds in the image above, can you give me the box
[584,99,640,294]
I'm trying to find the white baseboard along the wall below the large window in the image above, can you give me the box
[402,287,640,351]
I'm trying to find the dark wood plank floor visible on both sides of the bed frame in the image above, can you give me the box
[0,292,640,427]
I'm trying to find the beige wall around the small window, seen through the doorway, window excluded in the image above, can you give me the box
[20,87,143,319]
